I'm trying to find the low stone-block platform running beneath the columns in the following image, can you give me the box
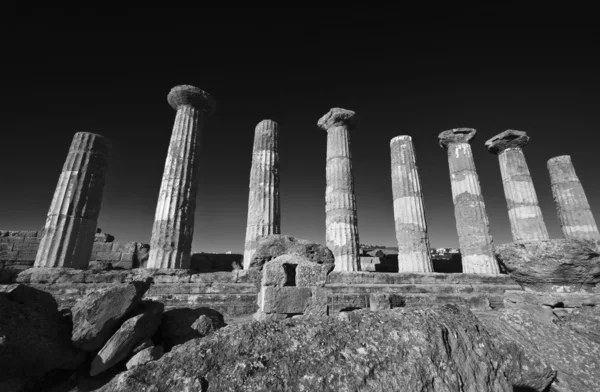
[8,268,521,318]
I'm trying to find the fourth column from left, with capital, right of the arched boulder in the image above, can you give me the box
[317,108,360,271]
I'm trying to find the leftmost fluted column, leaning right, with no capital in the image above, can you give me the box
[34,132,109,269]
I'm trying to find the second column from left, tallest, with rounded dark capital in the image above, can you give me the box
[147,85,215,268]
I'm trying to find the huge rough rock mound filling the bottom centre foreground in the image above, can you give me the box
[101,305,552,392]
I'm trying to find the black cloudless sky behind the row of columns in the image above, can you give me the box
[0,6,600,252]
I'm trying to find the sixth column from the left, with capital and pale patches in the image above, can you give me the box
[438,128,500,274]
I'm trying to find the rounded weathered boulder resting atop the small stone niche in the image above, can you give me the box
[250,235,334,270]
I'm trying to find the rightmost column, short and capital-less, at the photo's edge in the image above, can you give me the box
[548,155,600,241]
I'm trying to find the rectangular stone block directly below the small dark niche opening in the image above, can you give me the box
[259,287,312,313]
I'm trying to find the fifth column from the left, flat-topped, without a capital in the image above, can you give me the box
[390,135,433,272]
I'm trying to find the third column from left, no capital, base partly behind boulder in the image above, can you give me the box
[244,120,281,269]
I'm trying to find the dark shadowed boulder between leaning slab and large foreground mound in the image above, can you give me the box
[160,308,225,351]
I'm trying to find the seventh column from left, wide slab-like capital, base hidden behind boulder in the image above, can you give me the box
[485,129,549,241]
